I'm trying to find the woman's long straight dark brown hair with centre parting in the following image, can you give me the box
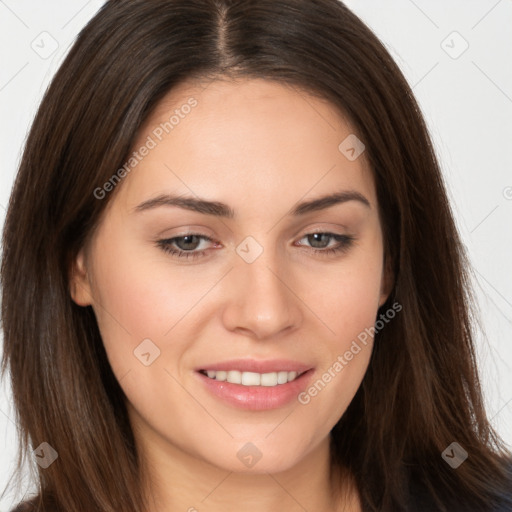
[1,0,512,512]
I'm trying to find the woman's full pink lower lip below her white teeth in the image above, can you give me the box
[196,369,313,411]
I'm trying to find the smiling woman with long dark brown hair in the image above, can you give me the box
[2,0,512,512]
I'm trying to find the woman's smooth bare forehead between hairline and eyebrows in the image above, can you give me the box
[116,79,375,212]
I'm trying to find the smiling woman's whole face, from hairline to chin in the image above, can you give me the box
[72,80,389,472]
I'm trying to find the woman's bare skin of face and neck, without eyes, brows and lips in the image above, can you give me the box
[71,79,390,512]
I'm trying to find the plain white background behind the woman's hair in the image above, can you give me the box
[0,0,512,511]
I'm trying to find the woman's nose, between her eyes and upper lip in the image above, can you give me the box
[222,249,303,339]
